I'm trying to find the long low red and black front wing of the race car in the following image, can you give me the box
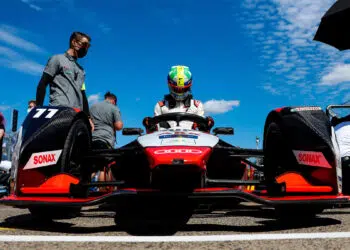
[0,188,350,208]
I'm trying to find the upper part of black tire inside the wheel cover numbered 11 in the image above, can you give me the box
[61,119,91,178]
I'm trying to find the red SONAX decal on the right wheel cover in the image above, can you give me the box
[293,150,332,168]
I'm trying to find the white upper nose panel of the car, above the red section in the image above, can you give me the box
[137,127,219,147]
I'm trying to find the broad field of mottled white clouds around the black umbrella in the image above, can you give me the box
[237,0,350,100]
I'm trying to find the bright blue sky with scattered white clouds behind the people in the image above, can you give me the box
[0,0,350,147]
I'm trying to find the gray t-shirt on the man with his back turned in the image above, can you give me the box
[90,101,121,147]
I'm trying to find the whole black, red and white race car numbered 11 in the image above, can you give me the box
[0,104,349,233]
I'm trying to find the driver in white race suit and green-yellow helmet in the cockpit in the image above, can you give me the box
[154,65,204,129]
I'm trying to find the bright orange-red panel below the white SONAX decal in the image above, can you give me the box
[20,174,79,194]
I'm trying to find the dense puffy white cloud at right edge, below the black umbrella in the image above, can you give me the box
[320,64,350,85]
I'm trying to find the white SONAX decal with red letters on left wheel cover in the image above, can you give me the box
[23,150,62,170]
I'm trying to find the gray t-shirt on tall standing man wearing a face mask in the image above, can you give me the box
[44,53,85,109]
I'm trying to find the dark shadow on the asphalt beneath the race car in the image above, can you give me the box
[0,205,341,234]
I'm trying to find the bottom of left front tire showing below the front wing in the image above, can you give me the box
[28,206,81,221]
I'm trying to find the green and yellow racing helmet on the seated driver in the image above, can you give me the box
[168,65,192,101]
